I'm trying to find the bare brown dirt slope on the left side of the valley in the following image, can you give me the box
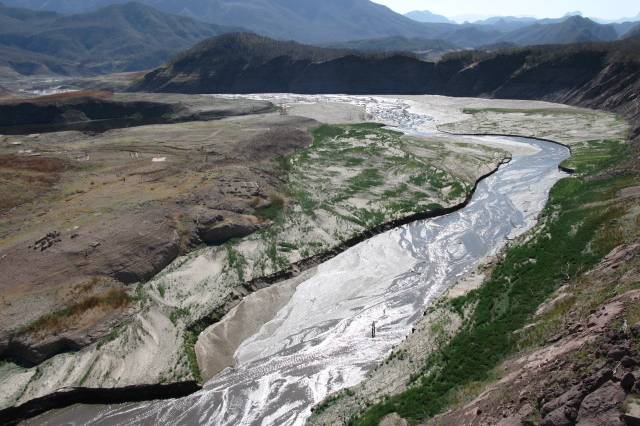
[0,96,314,365]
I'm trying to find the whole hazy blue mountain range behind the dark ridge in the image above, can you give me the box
[0,0,635,74]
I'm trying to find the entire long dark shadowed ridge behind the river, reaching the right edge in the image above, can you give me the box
[132,34,640,136]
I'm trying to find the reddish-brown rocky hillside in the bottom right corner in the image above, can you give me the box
[418,244,640,426]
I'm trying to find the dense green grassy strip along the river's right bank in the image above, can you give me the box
[351,136,640,425]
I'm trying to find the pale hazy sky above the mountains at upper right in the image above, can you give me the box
[373,0,640,19]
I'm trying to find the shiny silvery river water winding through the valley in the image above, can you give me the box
[30,98,569,425]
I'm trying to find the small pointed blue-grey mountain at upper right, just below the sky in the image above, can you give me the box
[500,16,618,46]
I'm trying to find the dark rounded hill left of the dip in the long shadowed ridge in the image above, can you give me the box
[132,34,432,93]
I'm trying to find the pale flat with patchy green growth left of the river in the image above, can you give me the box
[176,123,508,379]
